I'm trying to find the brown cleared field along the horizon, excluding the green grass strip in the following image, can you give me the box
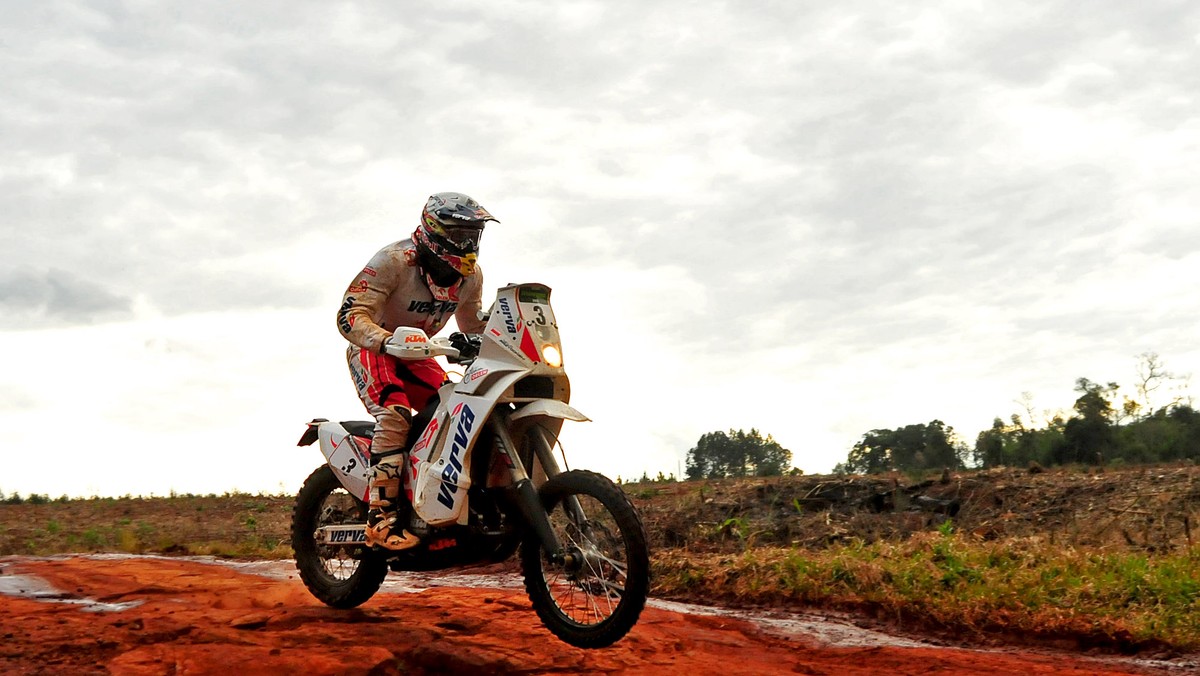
[0,465,1200,558]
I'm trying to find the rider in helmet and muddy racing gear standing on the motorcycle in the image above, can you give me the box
[337,192,499,551]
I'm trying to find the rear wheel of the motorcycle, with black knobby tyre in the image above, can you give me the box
[292,465,388,608]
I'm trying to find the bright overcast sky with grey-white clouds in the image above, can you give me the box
[0,0,1200,496]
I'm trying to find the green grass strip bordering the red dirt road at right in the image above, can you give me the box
[654,528,1200,651]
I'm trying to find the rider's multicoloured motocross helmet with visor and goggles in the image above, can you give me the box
[413,192,499,287]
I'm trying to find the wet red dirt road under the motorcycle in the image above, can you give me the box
[0,558,1180,676]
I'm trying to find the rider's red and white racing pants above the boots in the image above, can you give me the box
[346,345,446,455]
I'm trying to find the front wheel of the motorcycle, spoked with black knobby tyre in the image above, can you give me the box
[521,469,650,648]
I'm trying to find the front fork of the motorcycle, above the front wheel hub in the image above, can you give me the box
[491,409,583,567]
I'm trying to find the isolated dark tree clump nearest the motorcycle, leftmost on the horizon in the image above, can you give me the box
[686,429,792,480]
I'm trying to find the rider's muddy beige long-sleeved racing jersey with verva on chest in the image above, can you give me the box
[337,239,487,353]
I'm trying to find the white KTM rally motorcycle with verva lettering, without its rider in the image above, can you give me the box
[292,283,649,648]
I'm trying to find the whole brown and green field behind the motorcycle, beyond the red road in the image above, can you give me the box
[7,467,1200,652]
